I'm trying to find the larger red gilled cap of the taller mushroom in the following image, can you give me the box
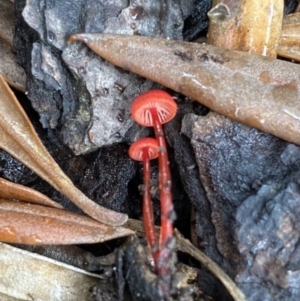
[131,90,177,126]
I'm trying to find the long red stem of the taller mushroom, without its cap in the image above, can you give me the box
[150,108,174,274]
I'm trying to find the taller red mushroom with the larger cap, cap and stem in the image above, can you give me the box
[131,90,177,273]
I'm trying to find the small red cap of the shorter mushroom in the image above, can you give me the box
[128,138,158,161]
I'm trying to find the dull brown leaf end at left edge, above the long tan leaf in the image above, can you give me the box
[0,39,26,92]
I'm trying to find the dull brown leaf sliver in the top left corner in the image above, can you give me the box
[0,0,15,46]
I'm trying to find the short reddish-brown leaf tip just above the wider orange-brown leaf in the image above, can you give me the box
[0,178,63,209]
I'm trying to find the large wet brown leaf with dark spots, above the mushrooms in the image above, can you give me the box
[69,34,300,144]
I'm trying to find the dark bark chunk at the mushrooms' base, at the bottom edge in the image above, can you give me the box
[124,239,206,301]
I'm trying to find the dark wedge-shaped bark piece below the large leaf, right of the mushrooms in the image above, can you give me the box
[192,113,287,275]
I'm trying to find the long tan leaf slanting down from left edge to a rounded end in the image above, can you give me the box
[0,75,127,226]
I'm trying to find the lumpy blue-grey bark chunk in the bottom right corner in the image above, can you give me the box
[236,180,300,301]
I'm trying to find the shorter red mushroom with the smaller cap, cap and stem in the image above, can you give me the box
[128,138,158,256]
